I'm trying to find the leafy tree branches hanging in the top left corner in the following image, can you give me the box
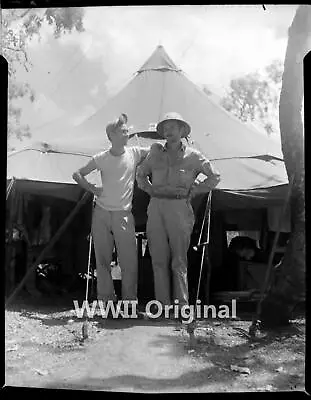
[1,7,84,150]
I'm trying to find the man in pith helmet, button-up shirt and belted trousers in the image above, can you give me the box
[137,112,220,312]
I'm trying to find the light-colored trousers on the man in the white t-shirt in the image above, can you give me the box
[92,205,138,301]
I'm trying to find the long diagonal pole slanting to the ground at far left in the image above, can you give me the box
[5,192,90,307]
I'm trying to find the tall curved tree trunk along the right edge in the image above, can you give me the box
[259,5,311,327]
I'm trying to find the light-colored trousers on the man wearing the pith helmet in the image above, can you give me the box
[147,198,194,305]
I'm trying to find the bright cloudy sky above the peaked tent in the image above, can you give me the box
[7,5,297,147]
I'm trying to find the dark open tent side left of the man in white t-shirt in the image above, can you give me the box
[5,186,92,299]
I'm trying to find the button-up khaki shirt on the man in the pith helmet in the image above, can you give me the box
[136,143,219,196]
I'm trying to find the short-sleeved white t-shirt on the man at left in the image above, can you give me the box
[93,146,142,211]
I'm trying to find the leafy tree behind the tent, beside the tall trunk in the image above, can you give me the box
[221,60,283,135]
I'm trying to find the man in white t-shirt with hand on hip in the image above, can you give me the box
[72,114,149,302]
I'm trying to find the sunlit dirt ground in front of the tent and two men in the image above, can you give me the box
[5,297,305,393]
